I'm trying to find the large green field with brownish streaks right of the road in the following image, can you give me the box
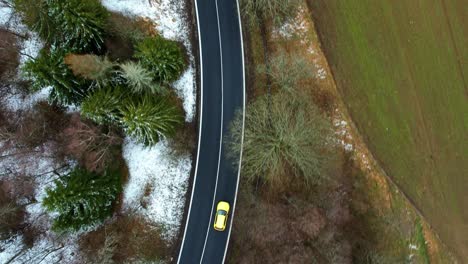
[309,0,468,262]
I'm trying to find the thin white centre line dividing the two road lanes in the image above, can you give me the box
[200,0,224,263]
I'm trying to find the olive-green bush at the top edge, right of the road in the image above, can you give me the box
[241,0,302,25]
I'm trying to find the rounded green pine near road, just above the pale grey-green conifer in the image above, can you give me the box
[134,36,186,83]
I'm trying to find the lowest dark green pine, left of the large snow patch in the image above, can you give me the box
[42,168,121,231]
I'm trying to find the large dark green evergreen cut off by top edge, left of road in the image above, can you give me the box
[14,0,108,52]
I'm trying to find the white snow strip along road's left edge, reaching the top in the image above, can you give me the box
[101,0,196,122]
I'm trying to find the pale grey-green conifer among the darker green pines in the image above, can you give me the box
[119,61,163,93]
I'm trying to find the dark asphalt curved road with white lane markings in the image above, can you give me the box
[177,0,245,264]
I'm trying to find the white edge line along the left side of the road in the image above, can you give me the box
[177,0,203,264]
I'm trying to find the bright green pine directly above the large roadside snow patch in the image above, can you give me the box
[120,95,183,146]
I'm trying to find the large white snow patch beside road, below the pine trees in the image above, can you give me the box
[123,139,192,240]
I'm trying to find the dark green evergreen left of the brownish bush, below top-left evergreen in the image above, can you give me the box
[24,49,90,105]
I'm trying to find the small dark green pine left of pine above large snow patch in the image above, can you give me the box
[81,87,126,125]
